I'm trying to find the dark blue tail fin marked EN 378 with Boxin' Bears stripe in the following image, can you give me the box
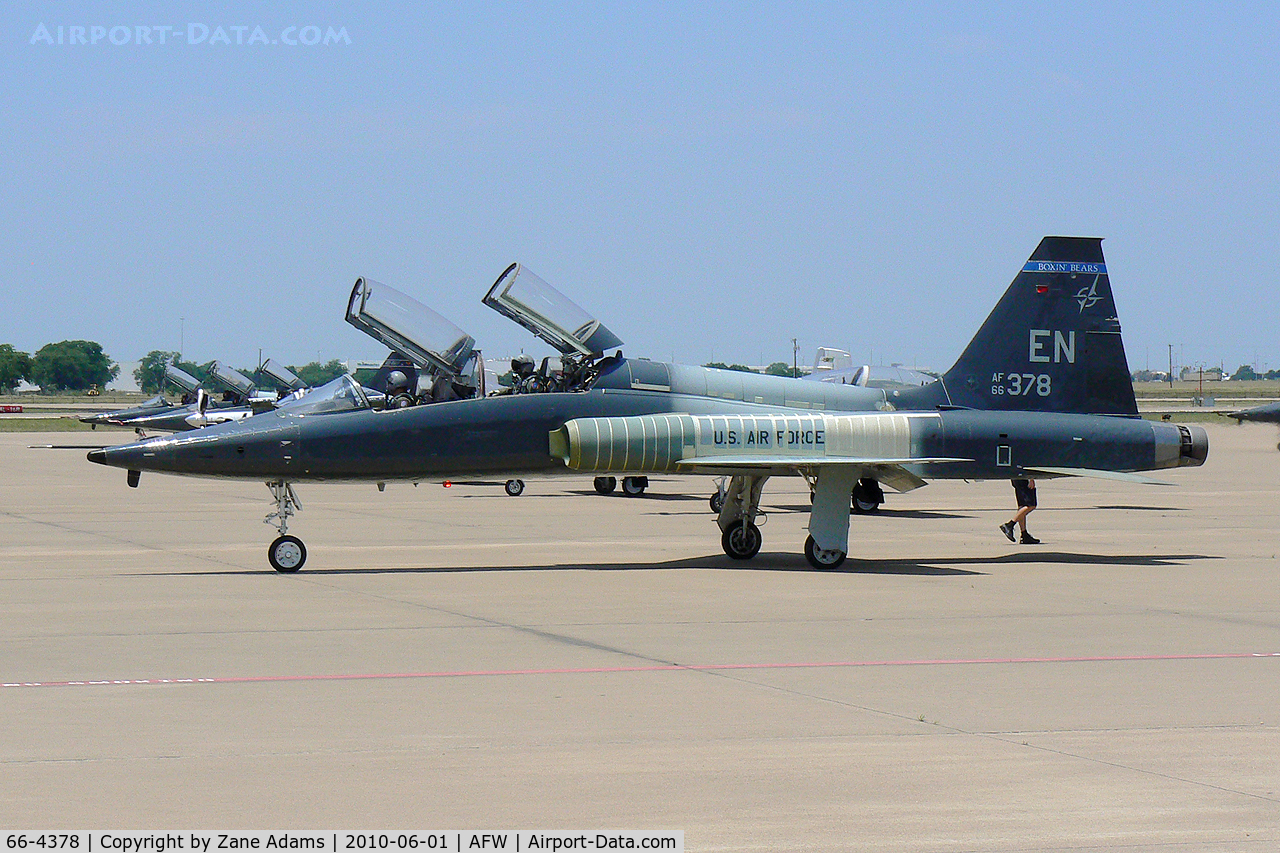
[921,237,1138,416]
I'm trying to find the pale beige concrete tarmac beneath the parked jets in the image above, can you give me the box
[0,425,1280,852]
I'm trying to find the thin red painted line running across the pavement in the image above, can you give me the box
[0,652,1280,688]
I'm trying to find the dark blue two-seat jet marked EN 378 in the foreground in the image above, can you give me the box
[88,237,1208,571]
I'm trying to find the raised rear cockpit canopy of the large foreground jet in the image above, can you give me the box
[484,258,622,355]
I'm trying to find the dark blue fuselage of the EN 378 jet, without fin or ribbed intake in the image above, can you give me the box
[90,380,1207,482]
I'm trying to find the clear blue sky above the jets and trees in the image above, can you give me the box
[0,3,1280,370]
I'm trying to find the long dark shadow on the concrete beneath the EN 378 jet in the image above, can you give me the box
[160,551,1222,578]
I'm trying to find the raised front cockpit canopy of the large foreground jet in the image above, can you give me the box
[347,278,476,377]
